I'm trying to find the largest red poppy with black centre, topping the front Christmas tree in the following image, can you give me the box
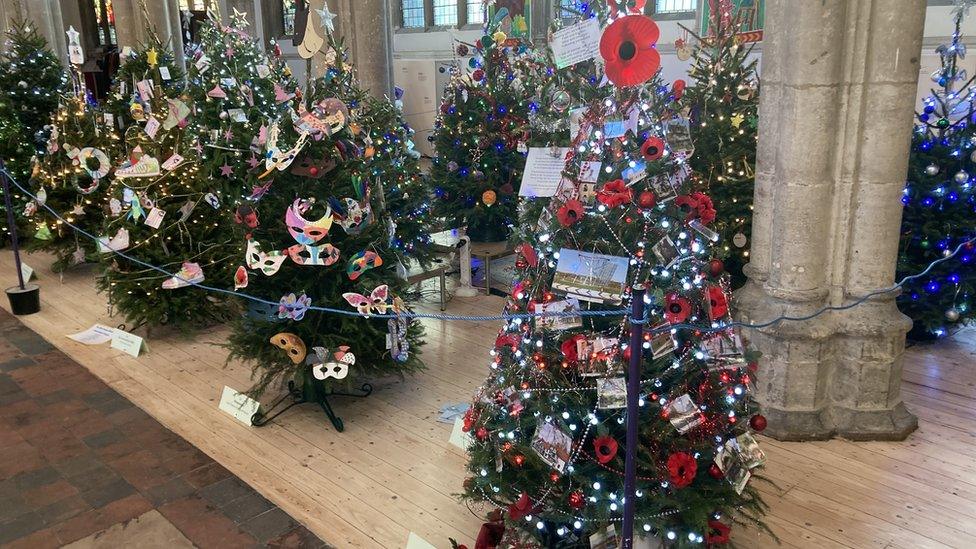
[600,15,661,87]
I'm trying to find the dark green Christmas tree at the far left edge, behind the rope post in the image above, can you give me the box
[0,17,69,181]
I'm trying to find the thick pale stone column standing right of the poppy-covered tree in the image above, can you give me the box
[738,0,925,440]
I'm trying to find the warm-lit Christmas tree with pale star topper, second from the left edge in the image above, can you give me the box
[22,72,127,270]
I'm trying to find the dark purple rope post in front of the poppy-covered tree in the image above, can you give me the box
[620,284,646,549]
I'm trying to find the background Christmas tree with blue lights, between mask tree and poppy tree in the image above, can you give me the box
[430,8,545,241]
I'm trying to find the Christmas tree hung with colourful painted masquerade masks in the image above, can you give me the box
[229,12,429,428]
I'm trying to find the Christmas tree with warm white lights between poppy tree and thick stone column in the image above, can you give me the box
[685,10,759,289]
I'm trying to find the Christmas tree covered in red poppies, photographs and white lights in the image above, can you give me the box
[464,4,765,547]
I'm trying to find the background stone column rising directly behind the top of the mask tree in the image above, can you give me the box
[336,0,393,97]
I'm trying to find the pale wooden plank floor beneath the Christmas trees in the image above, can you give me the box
[0,250,976,548]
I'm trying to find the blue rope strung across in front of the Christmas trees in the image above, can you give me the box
[0,169,976,334]
